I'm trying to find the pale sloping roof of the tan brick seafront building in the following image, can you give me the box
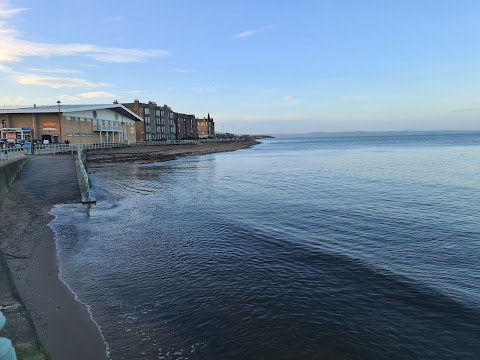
[0,104,143,121]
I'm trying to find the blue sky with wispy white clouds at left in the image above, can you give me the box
[0,0,480,134]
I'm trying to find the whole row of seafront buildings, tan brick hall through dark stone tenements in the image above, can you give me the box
[0,100,215,144]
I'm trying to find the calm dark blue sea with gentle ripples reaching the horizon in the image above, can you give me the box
[52,135,480,360]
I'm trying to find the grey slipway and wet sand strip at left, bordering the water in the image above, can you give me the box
[0,155,107,360]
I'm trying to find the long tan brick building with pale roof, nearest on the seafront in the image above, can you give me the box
[0,104,142,144]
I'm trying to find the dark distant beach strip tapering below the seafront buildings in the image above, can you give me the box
[87,140,259,166]
